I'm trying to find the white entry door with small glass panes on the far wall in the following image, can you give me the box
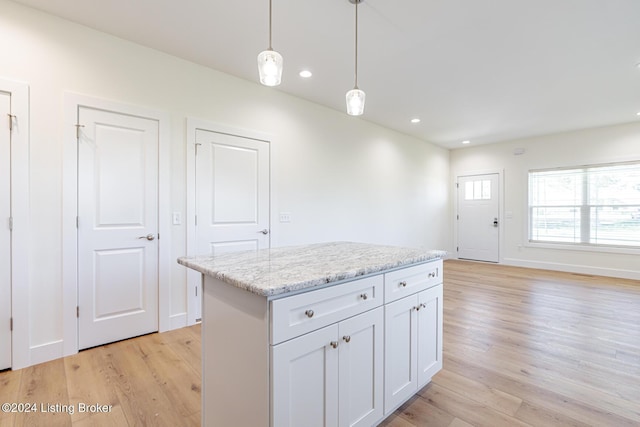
[457,173,500,262]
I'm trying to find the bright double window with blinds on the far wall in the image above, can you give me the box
[529,162,640,247]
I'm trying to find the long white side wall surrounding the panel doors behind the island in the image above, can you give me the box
[0,0,451,368]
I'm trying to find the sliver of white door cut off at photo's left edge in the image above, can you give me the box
[0,91,11,370]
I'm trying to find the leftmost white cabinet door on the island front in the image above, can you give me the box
[271,324,338,427]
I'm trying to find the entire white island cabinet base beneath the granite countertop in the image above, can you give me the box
[202,260,442,427]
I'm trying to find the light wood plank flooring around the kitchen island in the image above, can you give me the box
[0,260,640,427]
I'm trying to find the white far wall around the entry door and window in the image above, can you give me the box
[451,123,640,279]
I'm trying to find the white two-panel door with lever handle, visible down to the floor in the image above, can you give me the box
[78,107,159,349]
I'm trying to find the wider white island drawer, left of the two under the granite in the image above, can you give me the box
[271,275,384,345]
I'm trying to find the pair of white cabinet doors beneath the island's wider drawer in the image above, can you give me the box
[271,307,384,427]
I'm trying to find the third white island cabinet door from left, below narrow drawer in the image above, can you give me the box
[384,294,418,415]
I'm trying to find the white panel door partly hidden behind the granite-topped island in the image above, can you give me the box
[196,129,269,255]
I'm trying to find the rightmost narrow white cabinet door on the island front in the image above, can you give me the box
[418,285,442,388]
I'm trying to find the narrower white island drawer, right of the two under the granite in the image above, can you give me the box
[384,259,442,303]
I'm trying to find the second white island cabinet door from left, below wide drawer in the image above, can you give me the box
[338,307,384,427]
